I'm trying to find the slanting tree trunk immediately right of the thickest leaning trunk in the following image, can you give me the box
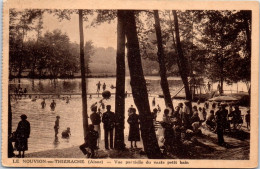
[154,10,173,110]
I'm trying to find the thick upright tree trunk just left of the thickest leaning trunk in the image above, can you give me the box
[114,10,125,150]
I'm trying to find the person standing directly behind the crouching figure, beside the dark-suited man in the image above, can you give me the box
[90,106,101,147]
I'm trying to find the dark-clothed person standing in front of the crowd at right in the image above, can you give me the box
[215,103,228,145]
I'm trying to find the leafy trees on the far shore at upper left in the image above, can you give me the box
[9,10,94,78]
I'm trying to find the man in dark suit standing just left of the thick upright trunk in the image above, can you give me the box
[102,105,115,150]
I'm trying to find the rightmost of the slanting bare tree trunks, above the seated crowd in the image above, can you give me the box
[172,10,191,101]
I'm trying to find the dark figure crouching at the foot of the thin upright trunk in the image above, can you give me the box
[79,124,98,158]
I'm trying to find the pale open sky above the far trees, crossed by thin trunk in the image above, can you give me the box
[32,13,117,49]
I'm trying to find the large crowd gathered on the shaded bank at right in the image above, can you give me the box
[157,101,250,149]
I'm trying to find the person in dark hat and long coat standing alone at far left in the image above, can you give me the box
[15,114,31,158]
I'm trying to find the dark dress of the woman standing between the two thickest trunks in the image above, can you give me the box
[127,114,140,141]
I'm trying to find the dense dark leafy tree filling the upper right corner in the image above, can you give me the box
[201,11,251,93]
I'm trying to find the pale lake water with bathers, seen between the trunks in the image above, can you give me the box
[9,77,246,152]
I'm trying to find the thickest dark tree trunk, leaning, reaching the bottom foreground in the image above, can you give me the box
[125,10,162,159]
